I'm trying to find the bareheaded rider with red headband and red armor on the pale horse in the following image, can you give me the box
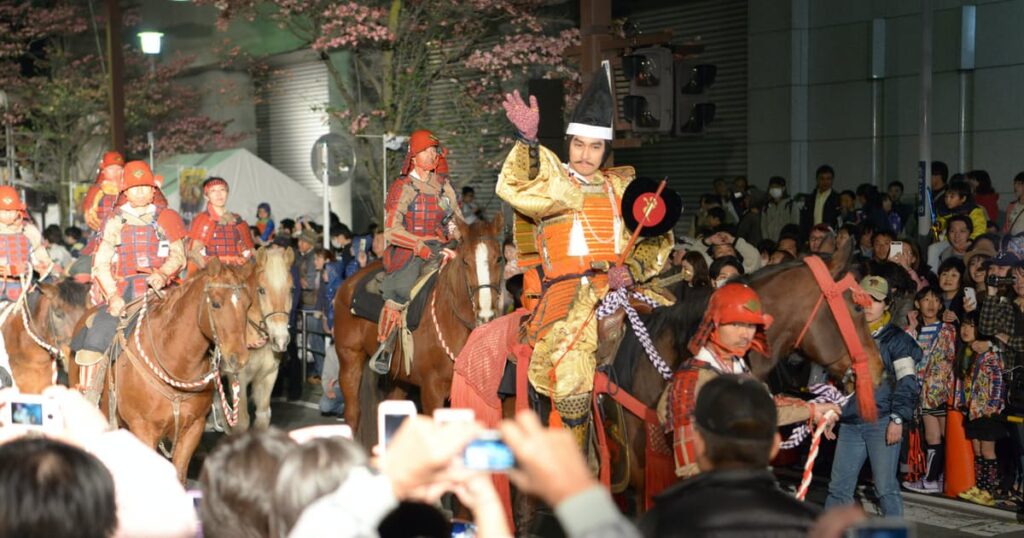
[188,177,254,268]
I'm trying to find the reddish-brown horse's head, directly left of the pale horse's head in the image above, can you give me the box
[196,258,254,373]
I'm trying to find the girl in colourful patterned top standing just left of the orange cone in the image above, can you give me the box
[903,287,956,493]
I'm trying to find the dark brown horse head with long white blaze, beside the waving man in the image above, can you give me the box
[452,213,505,325]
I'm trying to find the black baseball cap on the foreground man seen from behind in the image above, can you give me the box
[693,374,778,441]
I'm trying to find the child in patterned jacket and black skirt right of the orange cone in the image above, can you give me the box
[956,312,1007,506]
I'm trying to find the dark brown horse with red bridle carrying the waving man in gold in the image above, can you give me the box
[613,239,882,506]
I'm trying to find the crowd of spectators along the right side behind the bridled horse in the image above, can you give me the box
[671,161,1024,514]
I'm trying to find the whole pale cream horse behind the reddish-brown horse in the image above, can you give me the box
[222,246,295,433]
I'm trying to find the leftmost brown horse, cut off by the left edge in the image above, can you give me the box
[0,279,89,394]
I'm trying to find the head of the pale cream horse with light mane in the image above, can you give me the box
[248,246,295,353]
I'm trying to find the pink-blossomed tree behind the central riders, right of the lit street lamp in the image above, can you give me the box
[197,0,579,217]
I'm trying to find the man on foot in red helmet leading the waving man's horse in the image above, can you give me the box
[657,282,840,478]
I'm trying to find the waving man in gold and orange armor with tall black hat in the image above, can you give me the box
[496,68,673,452]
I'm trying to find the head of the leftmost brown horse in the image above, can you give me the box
[32,279,89,356]
